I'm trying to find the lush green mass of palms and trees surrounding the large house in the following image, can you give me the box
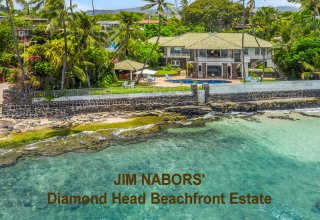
[0,0,320,94]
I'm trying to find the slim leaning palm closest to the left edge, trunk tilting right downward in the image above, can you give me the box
[6,0,28,93]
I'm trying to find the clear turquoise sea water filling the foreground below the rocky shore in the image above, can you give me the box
[0,112,320,220]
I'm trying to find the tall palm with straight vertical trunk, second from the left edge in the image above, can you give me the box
[42,0,68,90]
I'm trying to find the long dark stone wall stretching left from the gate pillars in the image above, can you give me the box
[2,85,198,119]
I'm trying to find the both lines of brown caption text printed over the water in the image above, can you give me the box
[48,173,272,205]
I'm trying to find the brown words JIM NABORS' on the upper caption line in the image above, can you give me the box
[113,173,205,186]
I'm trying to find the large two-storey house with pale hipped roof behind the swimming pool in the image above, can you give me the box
[149,33,274,79]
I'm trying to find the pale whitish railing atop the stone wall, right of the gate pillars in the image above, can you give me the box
[210,80,320,94]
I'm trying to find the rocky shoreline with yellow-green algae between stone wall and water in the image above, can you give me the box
[0,103,320,168]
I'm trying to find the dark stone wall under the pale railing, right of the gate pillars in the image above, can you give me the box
[206,89,320,102]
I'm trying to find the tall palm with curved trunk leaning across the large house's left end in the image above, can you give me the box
[136,0,174,83]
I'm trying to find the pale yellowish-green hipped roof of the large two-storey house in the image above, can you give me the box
[149,33,273,50]
